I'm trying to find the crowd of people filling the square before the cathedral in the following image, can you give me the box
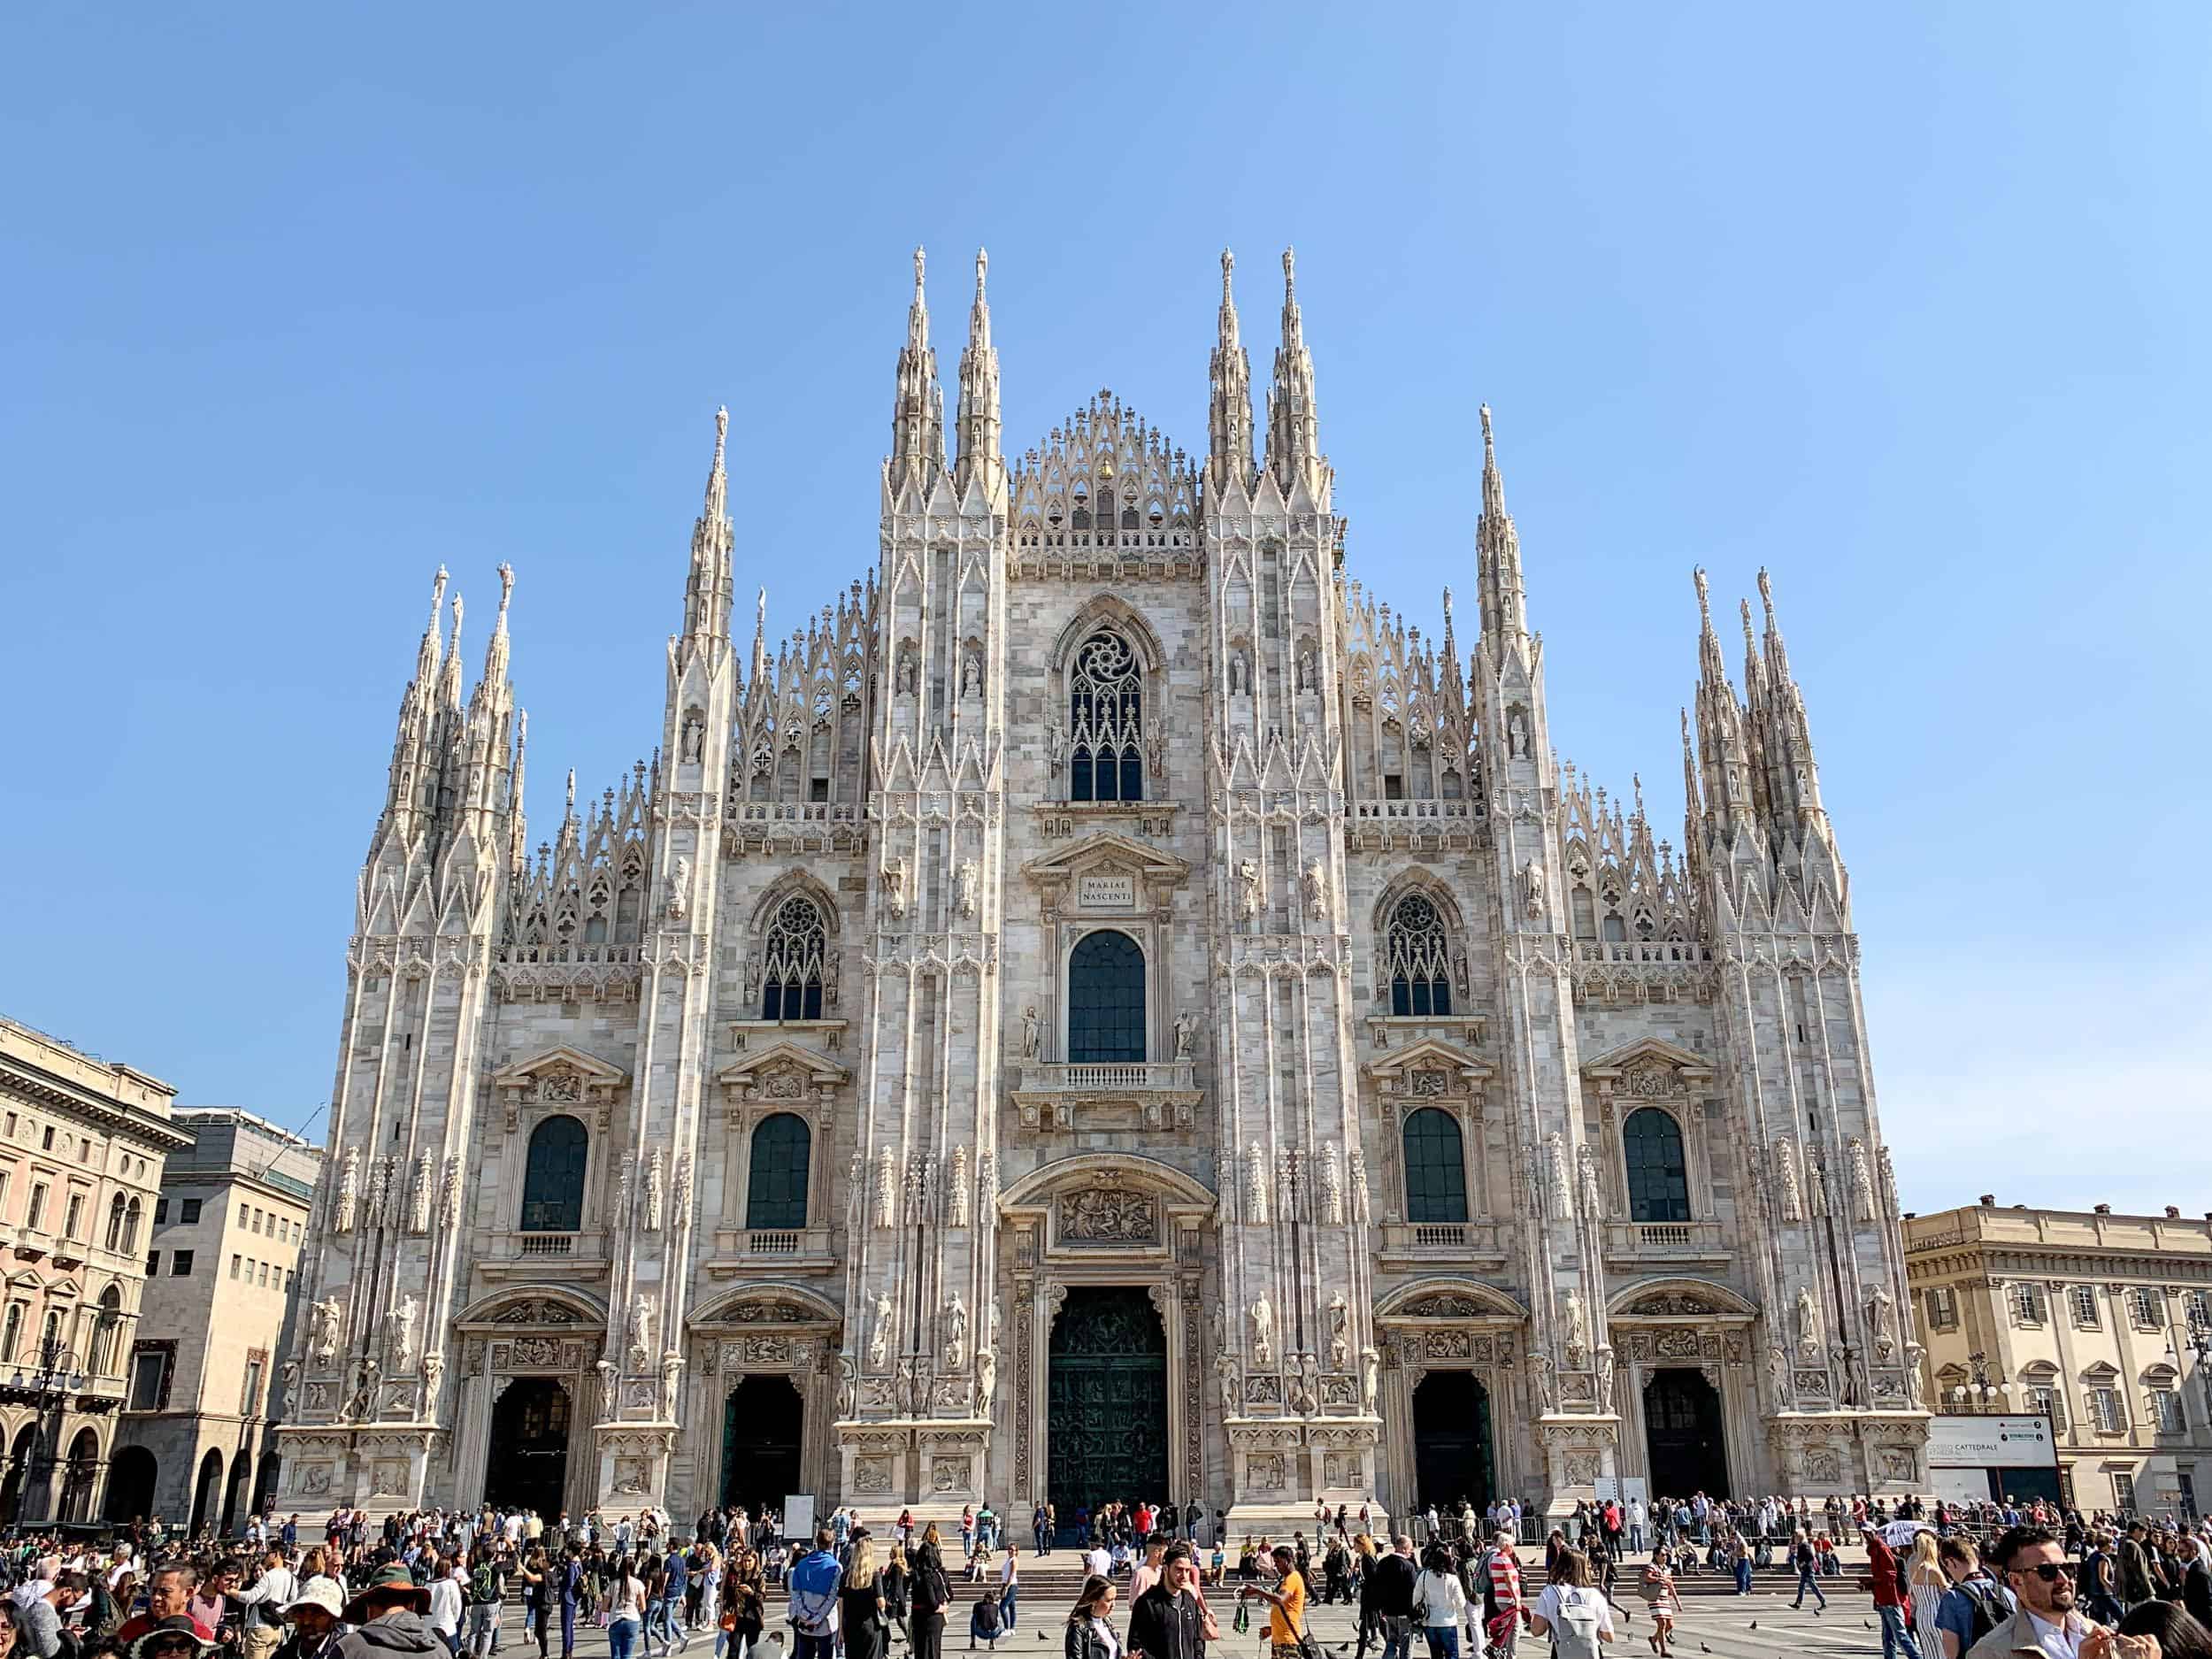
[12,1494,2212,1659]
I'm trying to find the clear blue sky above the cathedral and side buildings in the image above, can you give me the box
[0,3,2212,1215]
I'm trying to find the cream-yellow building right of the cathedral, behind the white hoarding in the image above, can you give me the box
[1905,1197,2212,1513]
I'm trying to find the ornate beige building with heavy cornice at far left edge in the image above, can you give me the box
[0,1020,188,1526]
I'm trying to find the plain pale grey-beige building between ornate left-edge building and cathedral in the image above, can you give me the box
[109,1109,323,1533]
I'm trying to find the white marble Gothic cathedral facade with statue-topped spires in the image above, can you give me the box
[281,255,1924,1520]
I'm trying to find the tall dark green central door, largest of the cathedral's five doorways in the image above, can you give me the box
[1044,1286,1172,1525]
